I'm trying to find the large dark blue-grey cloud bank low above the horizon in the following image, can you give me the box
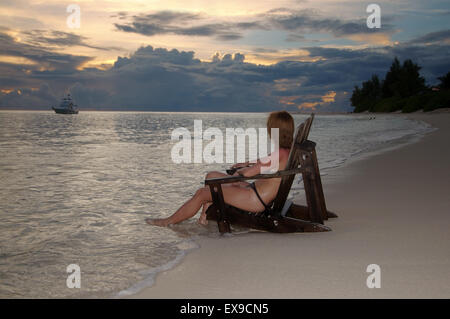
[0,28,450,111]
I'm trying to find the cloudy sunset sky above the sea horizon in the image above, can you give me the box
[0,0,450,111]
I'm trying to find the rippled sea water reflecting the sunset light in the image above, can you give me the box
[0,111,436,298]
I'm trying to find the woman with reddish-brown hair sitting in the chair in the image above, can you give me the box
[146,111,294,226]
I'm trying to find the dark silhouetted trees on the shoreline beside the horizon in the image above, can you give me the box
[350,58,450,113]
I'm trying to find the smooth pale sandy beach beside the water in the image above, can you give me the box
[131,113,450,298]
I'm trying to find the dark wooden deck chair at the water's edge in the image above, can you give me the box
[205,114,337,233]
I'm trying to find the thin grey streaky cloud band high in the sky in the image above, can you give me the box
[114,8,393,41]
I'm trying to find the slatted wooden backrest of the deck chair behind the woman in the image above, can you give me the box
[273,113,314,212]
